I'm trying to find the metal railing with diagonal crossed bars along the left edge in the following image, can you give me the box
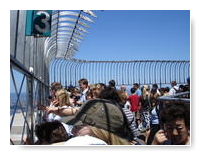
[10,56,49,145]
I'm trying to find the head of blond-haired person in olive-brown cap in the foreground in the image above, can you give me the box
[63,99,131,145]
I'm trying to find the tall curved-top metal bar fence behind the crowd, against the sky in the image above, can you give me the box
[49,59,190,86]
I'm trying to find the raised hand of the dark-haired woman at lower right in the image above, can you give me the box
[151,130,167,145]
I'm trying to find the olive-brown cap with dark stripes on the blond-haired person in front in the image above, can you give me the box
[62,99,130,138]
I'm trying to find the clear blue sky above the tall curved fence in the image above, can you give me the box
[75,10,190,60]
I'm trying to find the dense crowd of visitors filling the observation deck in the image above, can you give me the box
[26,79,190,145]
